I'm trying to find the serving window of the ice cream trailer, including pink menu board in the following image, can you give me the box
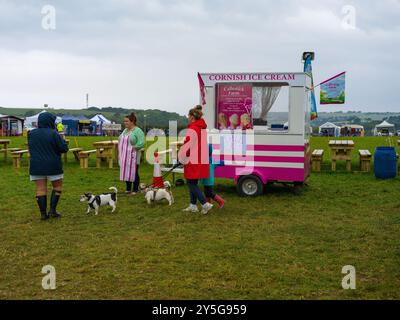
[216,83,289,131]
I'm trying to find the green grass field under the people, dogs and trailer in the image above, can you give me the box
[0,137,400,299]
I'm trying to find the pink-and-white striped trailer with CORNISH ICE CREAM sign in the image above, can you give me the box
[198,72,312,196]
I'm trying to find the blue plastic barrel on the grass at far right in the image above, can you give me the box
[374,147,397,179]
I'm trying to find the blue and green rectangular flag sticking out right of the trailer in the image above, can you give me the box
[320,72,346,104]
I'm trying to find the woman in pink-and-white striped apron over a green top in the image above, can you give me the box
[118,112,145,195]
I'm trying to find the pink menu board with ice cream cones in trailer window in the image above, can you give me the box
[217,84,253,130]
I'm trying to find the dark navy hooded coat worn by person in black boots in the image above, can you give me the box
[28,112,68,176]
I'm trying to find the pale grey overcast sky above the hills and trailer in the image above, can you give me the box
[0,0,400,114]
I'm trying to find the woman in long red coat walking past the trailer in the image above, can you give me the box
[179,106,213,214]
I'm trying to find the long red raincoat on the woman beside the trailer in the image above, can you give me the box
[179,119,210,180]
